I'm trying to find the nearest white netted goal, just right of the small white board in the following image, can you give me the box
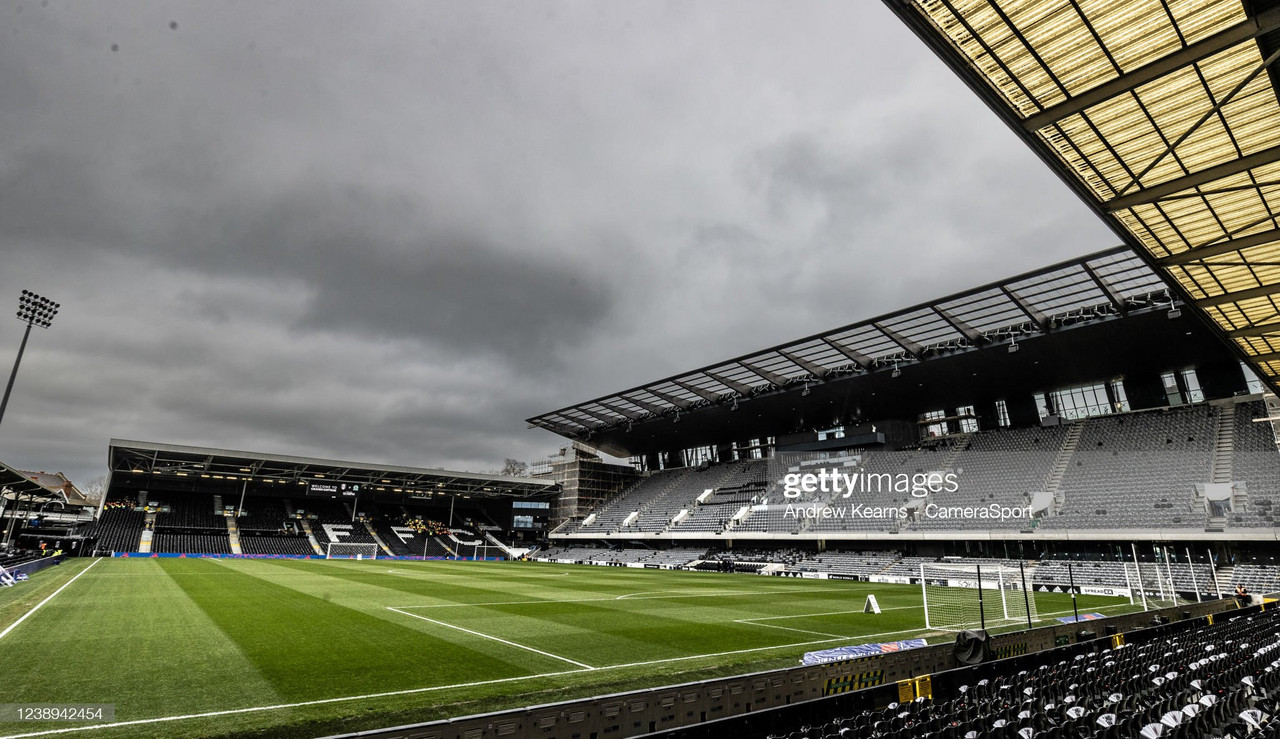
[920,564,1039,631]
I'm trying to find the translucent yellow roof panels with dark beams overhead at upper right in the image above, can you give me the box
[884,0,1280,389]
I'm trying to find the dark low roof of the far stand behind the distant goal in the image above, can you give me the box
[108,439,554,497]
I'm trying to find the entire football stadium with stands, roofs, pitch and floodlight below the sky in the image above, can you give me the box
[0,0,1280,739]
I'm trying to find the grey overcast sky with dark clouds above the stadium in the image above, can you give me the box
[0,0,1117,483]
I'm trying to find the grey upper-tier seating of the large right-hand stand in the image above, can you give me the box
[566,401,1280,537]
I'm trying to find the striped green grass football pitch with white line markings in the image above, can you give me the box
[0,558,1132,739]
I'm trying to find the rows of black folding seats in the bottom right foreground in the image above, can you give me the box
[769,611,1280,739]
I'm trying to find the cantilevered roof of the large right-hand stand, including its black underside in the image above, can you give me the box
[529,247,1231,456]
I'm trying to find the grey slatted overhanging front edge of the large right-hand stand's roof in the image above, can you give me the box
[529,247,1170,439]
